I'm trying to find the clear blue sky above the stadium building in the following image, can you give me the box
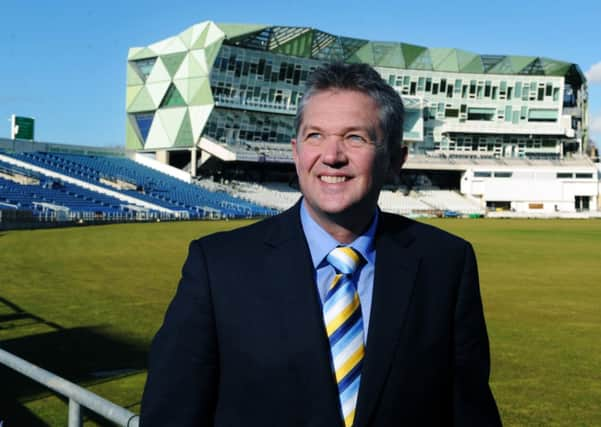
[0,0,601,147]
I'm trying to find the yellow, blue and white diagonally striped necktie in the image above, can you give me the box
[323,247,365,427]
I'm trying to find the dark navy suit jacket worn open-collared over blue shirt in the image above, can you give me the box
[141,204,500,427]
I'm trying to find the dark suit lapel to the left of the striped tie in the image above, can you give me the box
[265,204,341,426]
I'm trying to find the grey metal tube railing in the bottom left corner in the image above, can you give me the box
[0,349,139,427]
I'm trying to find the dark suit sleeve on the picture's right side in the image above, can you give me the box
[453,244,501,426]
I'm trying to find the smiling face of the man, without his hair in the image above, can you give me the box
[292,90,400,231]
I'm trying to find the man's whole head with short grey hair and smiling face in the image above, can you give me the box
[292,64,404,241]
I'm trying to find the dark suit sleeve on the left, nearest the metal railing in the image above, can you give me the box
[140,241,219,427]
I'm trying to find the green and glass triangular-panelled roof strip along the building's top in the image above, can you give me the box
[216,23,585,83]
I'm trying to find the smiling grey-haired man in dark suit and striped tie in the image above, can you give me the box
[141,64,500,427]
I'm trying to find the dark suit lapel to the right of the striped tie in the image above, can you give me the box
[354,214,419,426]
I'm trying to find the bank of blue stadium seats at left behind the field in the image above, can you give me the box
[3,152,276,219]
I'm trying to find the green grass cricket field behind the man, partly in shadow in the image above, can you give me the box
[0,220,601,426]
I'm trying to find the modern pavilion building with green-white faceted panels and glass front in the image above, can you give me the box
[126,21,588,174]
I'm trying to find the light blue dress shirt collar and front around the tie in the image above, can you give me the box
[300,200,378,342]
